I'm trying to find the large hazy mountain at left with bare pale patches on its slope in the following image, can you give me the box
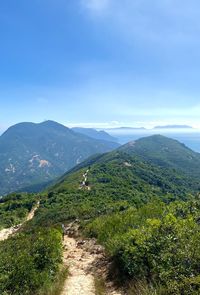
[0,121,119,195]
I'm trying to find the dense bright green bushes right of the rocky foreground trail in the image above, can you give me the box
[87,200,200,294]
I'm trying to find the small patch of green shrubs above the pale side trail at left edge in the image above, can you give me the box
[0,193,38,229]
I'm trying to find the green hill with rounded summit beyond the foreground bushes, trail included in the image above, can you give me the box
[31,136,200,229]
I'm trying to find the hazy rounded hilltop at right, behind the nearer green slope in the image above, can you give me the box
[120,135,200,178]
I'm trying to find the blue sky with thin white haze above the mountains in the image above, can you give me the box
[0,0,200,131]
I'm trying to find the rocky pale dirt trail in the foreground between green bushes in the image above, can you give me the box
[61,224,124,295]
